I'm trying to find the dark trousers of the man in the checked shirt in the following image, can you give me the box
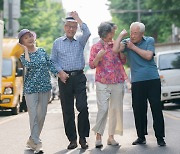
[58,73,90,141]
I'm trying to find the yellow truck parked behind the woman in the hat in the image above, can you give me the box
[0,38,27,115]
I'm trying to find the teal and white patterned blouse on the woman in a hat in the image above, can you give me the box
[20,48,58,94]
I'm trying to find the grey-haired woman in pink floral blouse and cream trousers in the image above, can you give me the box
[89,22,127,148]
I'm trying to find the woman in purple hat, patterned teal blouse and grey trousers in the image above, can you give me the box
[18,29,58,153]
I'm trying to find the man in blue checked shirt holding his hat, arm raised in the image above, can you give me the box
[51,11,90,149]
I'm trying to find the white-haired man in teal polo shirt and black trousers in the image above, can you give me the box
[113,22,166,146]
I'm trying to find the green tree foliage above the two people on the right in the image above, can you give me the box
[109,0,180,42]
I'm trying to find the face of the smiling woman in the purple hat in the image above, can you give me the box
[21,33,35,46]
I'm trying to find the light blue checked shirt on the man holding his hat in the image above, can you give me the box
[51,23,91,72]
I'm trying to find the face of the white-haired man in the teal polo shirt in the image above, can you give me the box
[130,26,144,43]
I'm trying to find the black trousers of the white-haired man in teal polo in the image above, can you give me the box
[132,79,165,138]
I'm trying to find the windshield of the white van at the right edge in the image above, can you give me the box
[159,52,180,70]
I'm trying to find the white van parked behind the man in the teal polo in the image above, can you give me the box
[155,50,180,107]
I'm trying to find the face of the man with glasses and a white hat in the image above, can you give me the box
[64,21,77,39]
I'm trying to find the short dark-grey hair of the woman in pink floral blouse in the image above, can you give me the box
[98,21,116,38]
